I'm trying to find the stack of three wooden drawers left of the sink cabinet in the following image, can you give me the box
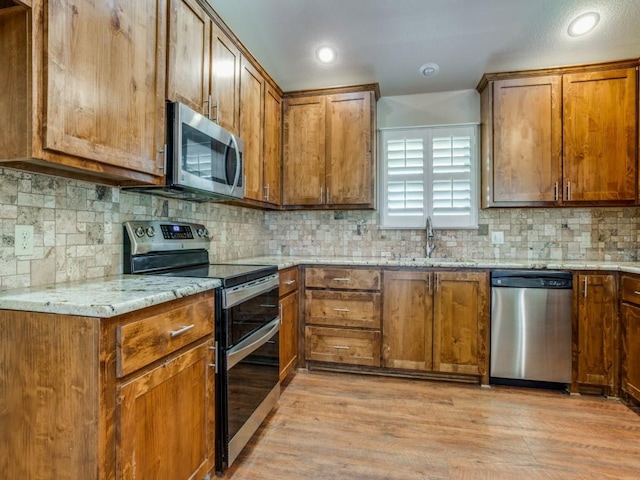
[305,267,381,367]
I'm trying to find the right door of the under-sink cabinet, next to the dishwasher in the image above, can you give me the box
[433,272,489,378]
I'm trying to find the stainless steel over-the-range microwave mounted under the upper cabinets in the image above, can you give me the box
[124,102,244,201]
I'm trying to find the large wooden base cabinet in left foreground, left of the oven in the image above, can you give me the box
[0,291,215,480]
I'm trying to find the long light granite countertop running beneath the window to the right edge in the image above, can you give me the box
[221,255,640,274]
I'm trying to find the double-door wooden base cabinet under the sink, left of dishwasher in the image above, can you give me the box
[382,270,489,384]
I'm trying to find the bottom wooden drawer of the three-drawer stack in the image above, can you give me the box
[305,327,380,367]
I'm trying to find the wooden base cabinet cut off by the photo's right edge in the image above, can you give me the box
[621,275,640,402]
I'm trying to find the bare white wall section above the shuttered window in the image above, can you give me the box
[378,90,480,128]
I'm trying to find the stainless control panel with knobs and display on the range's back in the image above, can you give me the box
[123,220,211,255]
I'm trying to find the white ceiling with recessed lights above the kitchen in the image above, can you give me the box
[208,0,640,96]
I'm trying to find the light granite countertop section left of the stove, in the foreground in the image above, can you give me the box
[0,275,220,318]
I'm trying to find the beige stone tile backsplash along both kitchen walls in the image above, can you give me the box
[0,168,639,290]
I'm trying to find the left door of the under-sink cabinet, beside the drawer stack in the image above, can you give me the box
[382,270,433,371]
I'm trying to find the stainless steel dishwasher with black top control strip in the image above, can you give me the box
[489,270,572,383]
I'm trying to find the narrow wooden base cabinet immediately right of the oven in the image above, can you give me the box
[279,267,300,382]
